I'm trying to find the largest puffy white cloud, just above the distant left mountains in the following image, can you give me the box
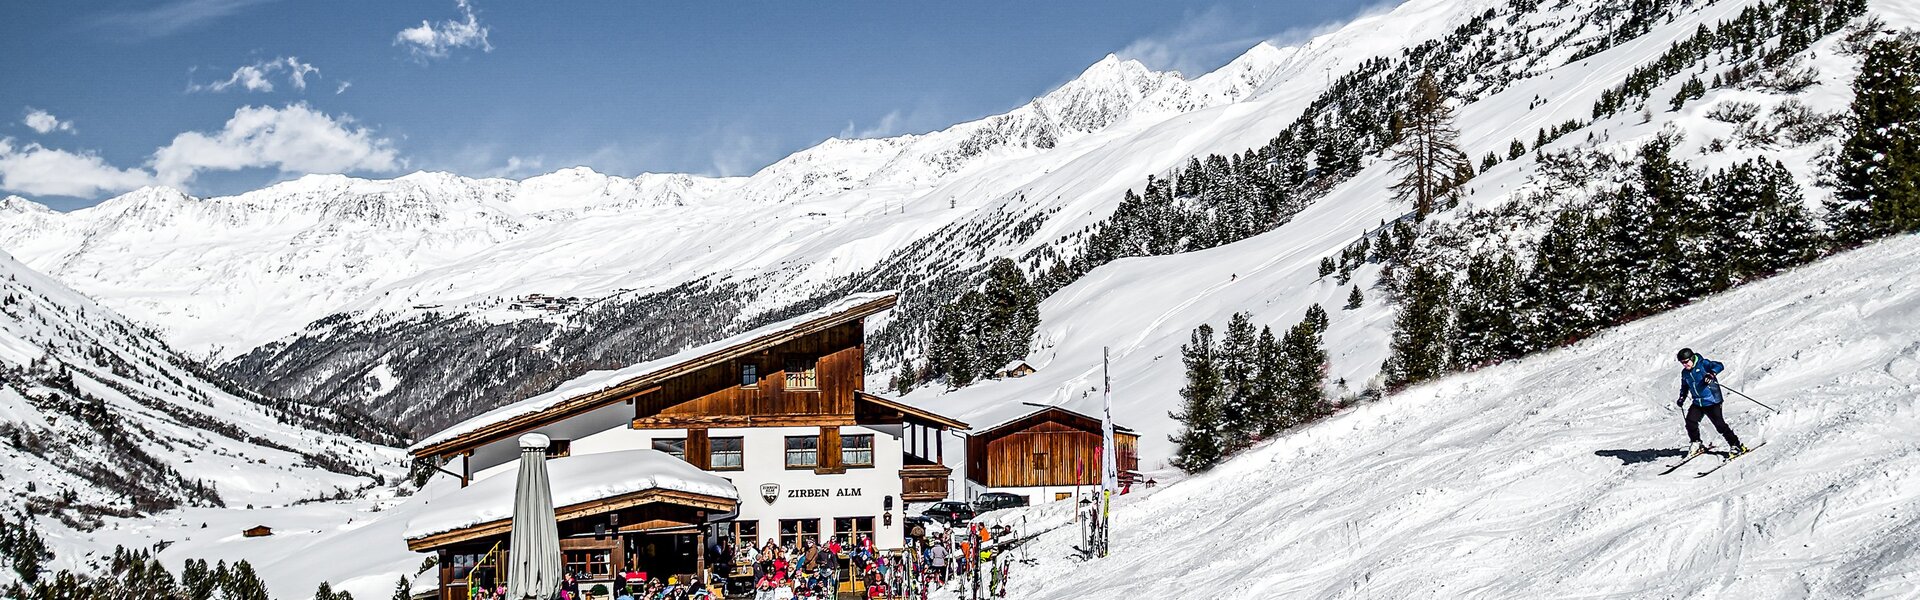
[150,104,405,187]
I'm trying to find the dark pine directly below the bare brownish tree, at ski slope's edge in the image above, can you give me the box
[1382,267,1452,385]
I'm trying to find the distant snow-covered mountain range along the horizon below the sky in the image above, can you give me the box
[0,46,1284,356]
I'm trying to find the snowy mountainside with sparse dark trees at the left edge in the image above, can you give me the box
[0,254,405,534]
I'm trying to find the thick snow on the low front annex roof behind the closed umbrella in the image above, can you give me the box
[405,450,739,540]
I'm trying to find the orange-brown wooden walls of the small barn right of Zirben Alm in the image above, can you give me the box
[966,408,1140,488]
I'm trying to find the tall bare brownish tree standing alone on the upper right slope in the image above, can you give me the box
[1390,71,1473,217]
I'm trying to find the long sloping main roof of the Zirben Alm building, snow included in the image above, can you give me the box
[407,292,899,456]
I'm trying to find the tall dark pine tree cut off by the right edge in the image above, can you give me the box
[1828,33,1920,244]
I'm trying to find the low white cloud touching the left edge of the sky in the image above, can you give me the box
[0,138,154,198]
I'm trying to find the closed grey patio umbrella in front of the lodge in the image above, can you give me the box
[507,433,561,600]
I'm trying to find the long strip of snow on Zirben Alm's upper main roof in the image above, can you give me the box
[407,290,895,452]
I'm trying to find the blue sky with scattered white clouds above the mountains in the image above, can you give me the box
[0,0,1379,210]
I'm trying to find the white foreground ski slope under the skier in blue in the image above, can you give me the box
[996,235,1920,600]
